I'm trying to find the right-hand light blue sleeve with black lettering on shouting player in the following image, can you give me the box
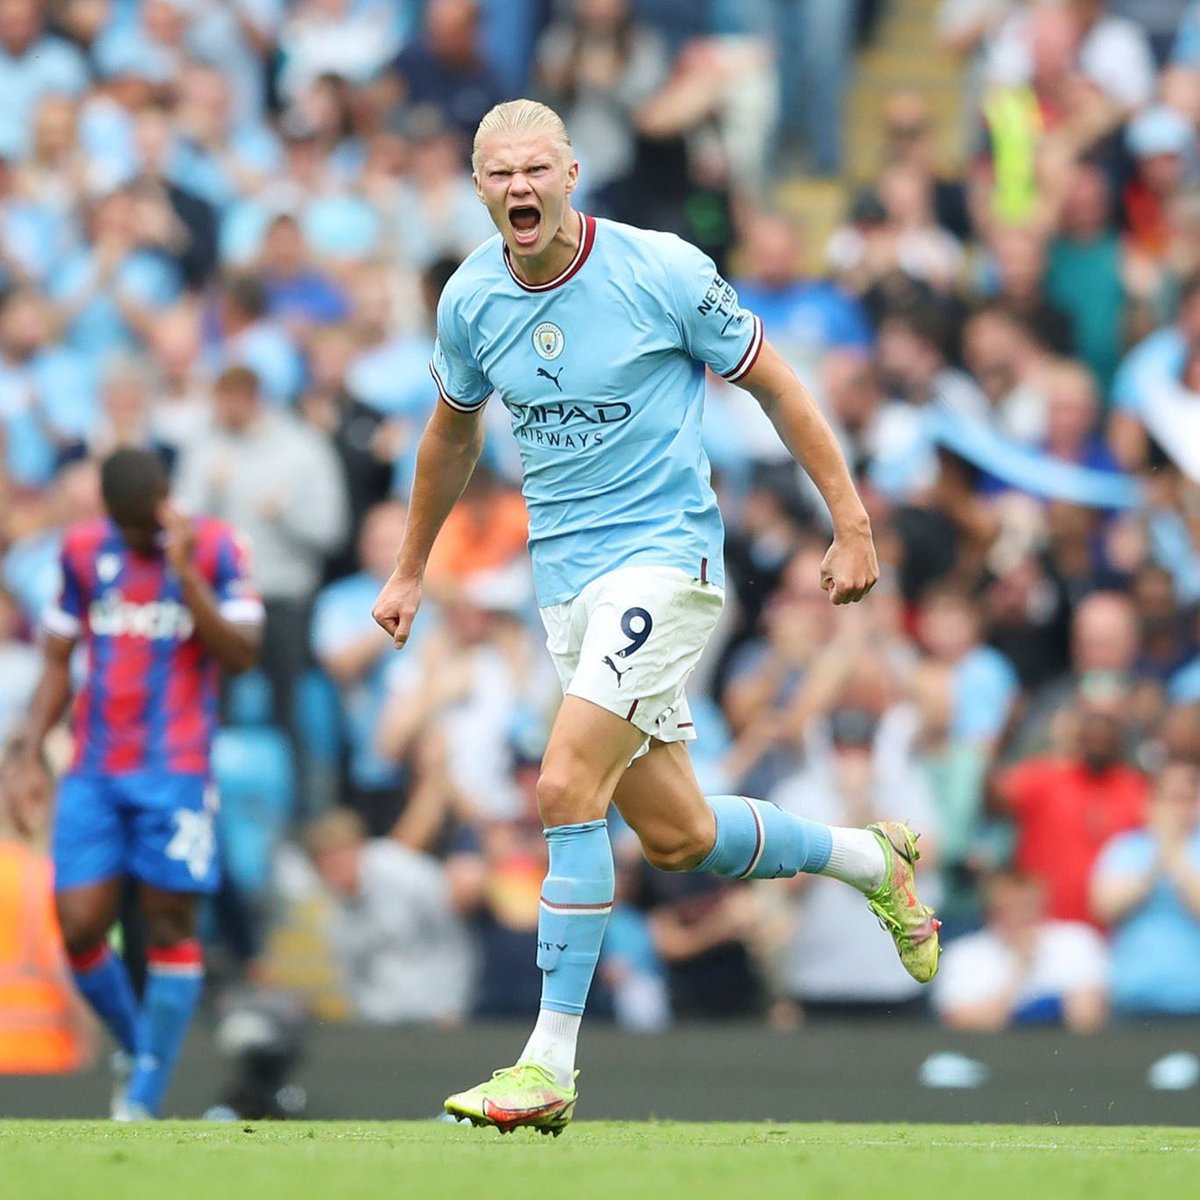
[670,241,763,383]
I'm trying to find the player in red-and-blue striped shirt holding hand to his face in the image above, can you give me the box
[11,450,263,1120]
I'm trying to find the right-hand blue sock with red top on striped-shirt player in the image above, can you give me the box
[128,941,204,1116]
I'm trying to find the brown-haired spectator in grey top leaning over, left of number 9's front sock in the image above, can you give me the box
[305,809,472,1025]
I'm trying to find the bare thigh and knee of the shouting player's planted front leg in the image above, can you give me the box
[538,696,646,828]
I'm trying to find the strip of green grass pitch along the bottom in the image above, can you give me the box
[0,1121,1200,1200]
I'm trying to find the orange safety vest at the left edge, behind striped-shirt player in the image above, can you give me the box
[0,841,84,1075]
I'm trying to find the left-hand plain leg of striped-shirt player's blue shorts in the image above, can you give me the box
[52,774,128,894]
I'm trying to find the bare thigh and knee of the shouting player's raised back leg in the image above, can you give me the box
[613,740,716,870]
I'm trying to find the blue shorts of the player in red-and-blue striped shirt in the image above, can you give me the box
[54,772,220,892]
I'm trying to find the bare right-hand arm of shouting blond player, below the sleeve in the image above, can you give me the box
[737,338,880,604]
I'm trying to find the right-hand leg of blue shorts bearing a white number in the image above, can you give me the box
[121,772,220,894]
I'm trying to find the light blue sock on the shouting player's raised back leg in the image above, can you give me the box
[696,796,833,880]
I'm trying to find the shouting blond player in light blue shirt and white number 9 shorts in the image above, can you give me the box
[373,100,938,1134]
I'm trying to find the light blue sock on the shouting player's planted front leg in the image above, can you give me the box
[538,821,613,1016]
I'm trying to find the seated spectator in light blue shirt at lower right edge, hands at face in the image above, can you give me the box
[1091,760,1200,1016]
